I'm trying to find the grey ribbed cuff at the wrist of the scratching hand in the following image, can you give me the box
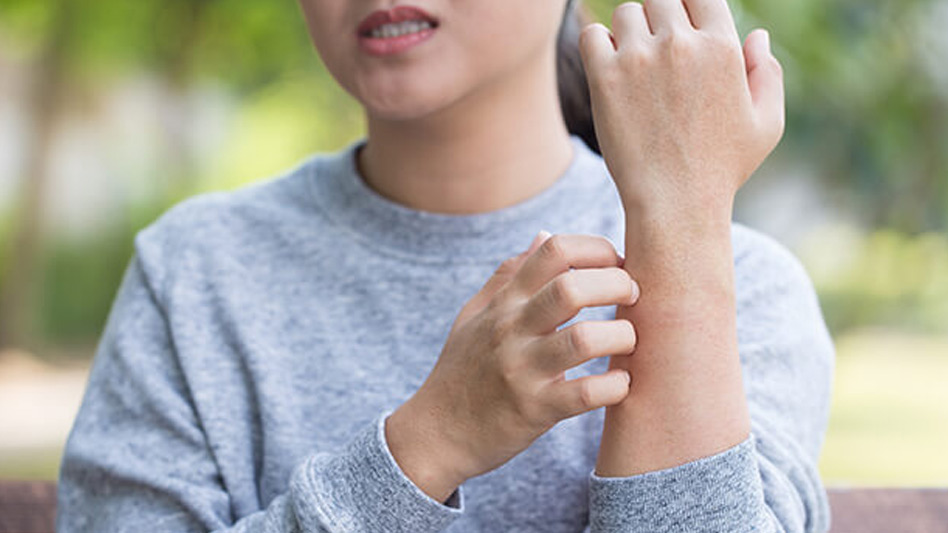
[291,410,464,533]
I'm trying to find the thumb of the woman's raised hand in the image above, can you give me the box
[744,29,785,138]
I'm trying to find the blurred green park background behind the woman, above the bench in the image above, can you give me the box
[0,0,948,485]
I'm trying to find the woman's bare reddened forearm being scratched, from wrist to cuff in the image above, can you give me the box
[596,205,750,477]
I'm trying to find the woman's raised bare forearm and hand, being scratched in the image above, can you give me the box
[580,0,784,477]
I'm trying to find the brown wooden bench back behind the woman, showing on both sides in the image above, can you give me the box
[0,481,948,533]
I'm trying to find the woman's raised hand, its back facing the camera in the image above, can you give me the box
[580,0,784,220]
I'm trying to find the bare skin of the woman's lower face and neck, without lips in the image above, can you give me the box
[300,0,572,214]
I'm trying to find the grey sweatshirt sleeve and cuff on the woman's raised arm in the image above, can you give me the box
[589,229,835,533]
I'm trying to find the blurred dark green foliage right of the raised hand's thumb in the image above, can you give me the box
[740,0,948,233]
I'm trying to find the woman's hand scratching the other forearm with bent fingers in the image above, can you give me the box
[386,231,638,501]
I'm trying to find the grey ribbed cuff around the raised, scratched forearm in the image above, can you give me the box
[589,437,767,533]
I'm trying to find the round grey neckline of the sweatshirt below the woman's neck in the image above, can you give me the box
[307,135,611,262]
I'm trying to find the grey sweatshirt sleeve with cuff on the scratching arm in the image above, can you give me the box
[57,256,464,533]
